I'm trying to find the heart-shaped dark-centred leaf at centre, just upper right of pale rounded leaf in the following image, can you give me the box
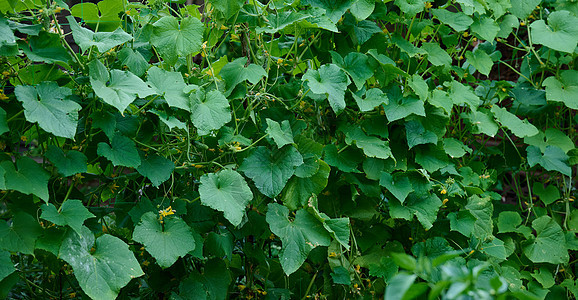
[239,146,303,198]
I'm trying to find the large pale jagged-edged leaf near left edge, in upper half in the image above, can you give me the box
[14,81,82,139]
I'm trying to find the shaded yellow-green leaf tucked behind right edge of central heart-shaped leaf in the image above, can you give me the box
[281,160,331,210]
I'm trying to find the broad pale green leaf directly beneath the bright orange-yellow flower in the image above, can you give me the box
[132,212,196,268]
